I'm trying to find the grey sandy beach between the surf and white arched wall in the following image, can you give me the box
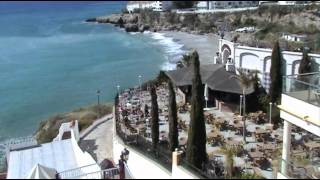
[161,31,230,64]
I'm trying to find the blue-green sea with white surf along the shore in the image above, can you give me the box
[0,1,182,141]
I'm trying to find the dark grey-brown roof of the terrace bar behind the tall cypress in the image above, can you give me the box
[166,64,254,94]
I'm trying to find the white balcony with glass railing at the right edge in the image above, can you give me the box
[279,73,320,128]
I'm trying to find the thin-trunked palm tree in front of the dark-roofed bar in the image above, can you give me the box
[231,69,259,143]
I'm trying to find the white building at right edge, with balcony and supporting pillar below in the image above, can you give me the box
[277,72,320,179]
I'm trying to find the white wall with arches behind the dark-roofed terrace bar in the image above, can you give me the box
[215,39,320,90]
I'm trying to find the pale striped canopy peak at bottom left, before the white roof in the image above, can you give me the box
[26,164,57,179]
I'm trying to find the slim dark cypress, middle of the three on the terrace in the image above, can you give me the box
[168,81,179,151]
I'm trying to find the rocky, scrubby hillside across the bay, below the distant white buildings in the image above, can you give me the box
[88,4,320,51]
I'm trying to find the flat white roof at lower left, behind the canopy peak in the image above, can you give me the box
[7,139,78,179]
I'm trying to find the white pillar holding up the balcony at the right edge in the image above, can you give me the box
[281,120,292,175]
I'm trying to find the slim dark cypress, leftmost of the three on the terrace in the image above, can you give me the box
[150,85,159,150]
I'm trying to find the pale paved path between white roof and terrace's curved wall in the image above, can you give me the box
[80,116,113,163]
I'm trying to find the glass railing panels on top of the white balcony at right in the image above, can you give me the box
[282,73,320,107]
